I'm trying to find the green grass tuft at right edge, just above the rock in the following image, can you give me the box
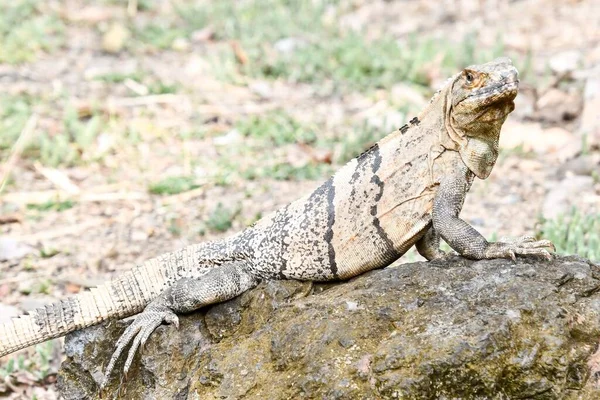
[540,208,600,261]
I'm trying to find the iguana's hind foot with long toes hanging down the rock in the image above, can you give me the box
[100,304,179,390]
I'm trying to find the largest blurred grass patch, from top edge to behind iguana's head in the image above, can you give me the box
[134,0,505,91]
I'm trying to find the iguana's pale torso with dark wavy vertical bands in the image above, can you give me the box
[241,92,459,280]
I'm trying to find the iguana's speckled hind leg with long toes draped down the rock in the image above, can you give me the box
[100,262,258,390]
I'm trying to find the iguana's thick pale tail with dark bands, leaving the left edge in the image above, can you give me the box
[0,256,169,357]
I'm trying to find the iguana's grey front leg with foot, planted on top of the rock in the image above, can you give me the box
[432,166,554,260]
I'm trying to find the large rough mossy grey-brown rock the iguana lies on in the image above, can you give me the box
[59,256,600,400]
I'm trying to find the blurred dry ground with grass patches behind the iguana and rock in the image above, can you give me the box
[0,0,600,399]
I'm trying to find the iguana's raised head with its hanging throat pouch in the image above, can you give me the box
[445,58,519,179]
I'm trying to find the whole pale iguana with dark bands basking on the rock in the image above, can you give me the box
[0,58,554,386]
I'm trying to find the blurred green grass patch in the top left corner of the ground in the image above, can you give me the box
[0,0,64,64]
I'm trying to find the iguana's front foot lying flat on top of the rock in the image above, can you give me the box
[485,236,556,261]
